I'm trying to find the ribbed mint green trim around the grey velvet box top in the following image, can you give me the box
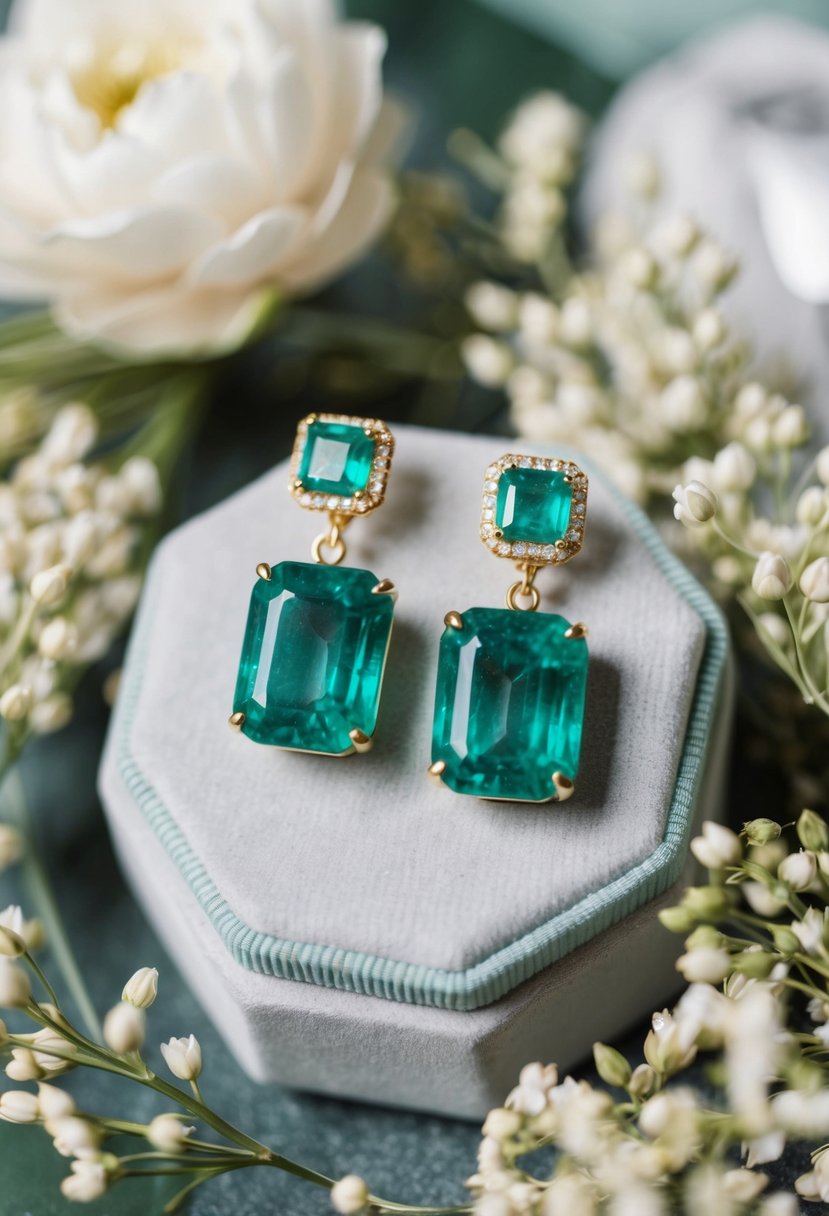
[113,462,729,1010]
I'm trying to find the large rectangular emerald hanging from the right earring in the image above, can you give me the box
[432,608,587,803]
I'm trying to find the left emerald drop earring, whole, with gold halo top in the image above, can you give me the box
[230,415,397,756]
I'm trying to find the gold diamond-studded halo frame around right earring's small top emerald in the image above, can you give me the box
[480,452,588,565]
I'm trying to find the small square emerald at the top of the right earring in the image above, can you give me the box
[495,468,573,545]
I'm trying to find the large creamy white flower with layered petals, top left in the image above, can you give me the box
[0,0,394,355]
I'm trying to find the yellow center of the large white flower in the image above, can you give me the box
[72,40,185,130]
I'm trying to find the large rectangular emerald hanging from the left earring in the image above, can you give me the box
[233,562,394,755]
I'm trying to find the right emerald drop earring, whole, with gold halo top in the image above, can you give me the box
[429,455,588,803]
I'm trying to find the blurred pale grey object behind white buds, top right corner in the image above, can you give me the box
[581,17,829,439]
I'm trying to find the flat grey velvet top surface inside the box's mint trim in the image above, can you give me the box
[110,430,704,969]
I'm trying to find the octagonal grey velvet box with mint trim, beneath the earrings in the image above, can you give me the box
[101,427,732,1118]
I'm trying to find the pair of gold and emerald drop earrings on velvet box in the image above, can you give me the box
[230,413,587,803]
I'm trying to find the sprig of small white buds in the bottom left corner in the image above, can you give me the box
[0,948,470,1216]
